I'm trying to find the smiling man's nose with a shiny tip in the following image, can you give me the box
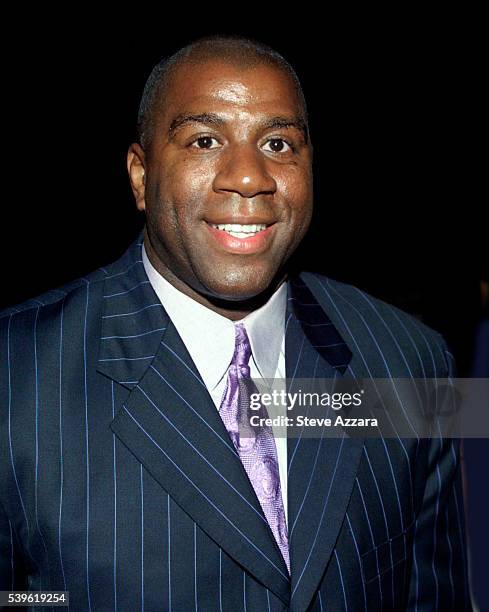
[213,145,277,198]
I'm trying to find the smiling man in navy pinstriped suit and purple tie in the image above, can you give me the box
[0,37,471,611]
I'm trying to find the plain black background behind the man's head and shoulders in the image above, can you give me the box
[0,17,489,598]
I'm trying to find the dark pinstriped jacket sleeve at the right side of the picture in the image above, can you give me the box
[407,342,472,612]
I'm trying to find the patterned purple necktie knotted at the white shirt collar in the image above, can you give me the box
[219,323,290,574]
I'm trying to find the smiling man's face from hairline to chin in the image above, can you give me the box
[130,60,313,300]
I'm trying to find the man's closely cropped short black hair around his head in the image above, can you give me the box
[137,34,309,150]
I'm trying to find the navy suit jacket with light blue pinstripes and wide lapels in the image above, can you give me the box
[0,233,471,612]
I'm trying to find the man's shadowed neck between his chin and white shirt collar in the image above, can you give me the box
[144,232,287,321]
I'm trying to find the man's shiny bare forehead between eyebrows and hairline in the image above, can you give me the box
[158,60,302,121]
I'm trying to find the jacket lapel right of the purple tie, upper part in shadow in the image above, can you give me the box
[285,274,363,611]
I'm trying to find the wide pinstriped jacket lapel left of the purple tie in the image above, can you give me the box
[98,231,290,604]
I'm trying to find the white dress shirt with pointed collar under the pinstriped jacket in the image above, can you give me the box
[142,244,287,517]
